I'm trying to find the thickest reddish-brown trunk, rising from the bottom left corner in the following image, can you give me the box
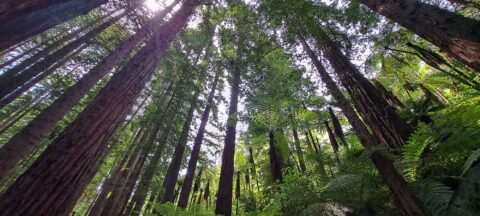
[0,0,199,215]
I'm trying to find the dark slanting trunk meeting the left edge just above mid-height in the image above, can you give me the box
[0,11,128,103]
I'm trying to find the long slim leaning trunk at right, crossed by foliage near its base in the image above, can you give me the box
[300,37,426,216]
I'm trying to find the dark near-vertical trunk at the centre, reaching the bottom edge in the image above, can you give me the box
[215,62,241,216]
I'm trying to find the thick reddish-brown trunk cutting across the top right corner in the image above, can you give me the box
[359,0,480,73]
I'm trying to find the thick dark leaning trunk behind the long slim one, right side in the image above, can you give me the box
[317,34,412,148]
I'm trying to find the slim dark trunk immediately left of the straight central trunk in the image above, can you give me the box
[178,73,220,208]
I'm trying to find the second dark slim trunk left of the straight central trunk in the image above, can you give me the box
[160,90,200,203]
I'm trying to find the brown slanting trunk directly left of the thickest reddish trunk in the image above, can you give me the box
[0,0,177,187]
